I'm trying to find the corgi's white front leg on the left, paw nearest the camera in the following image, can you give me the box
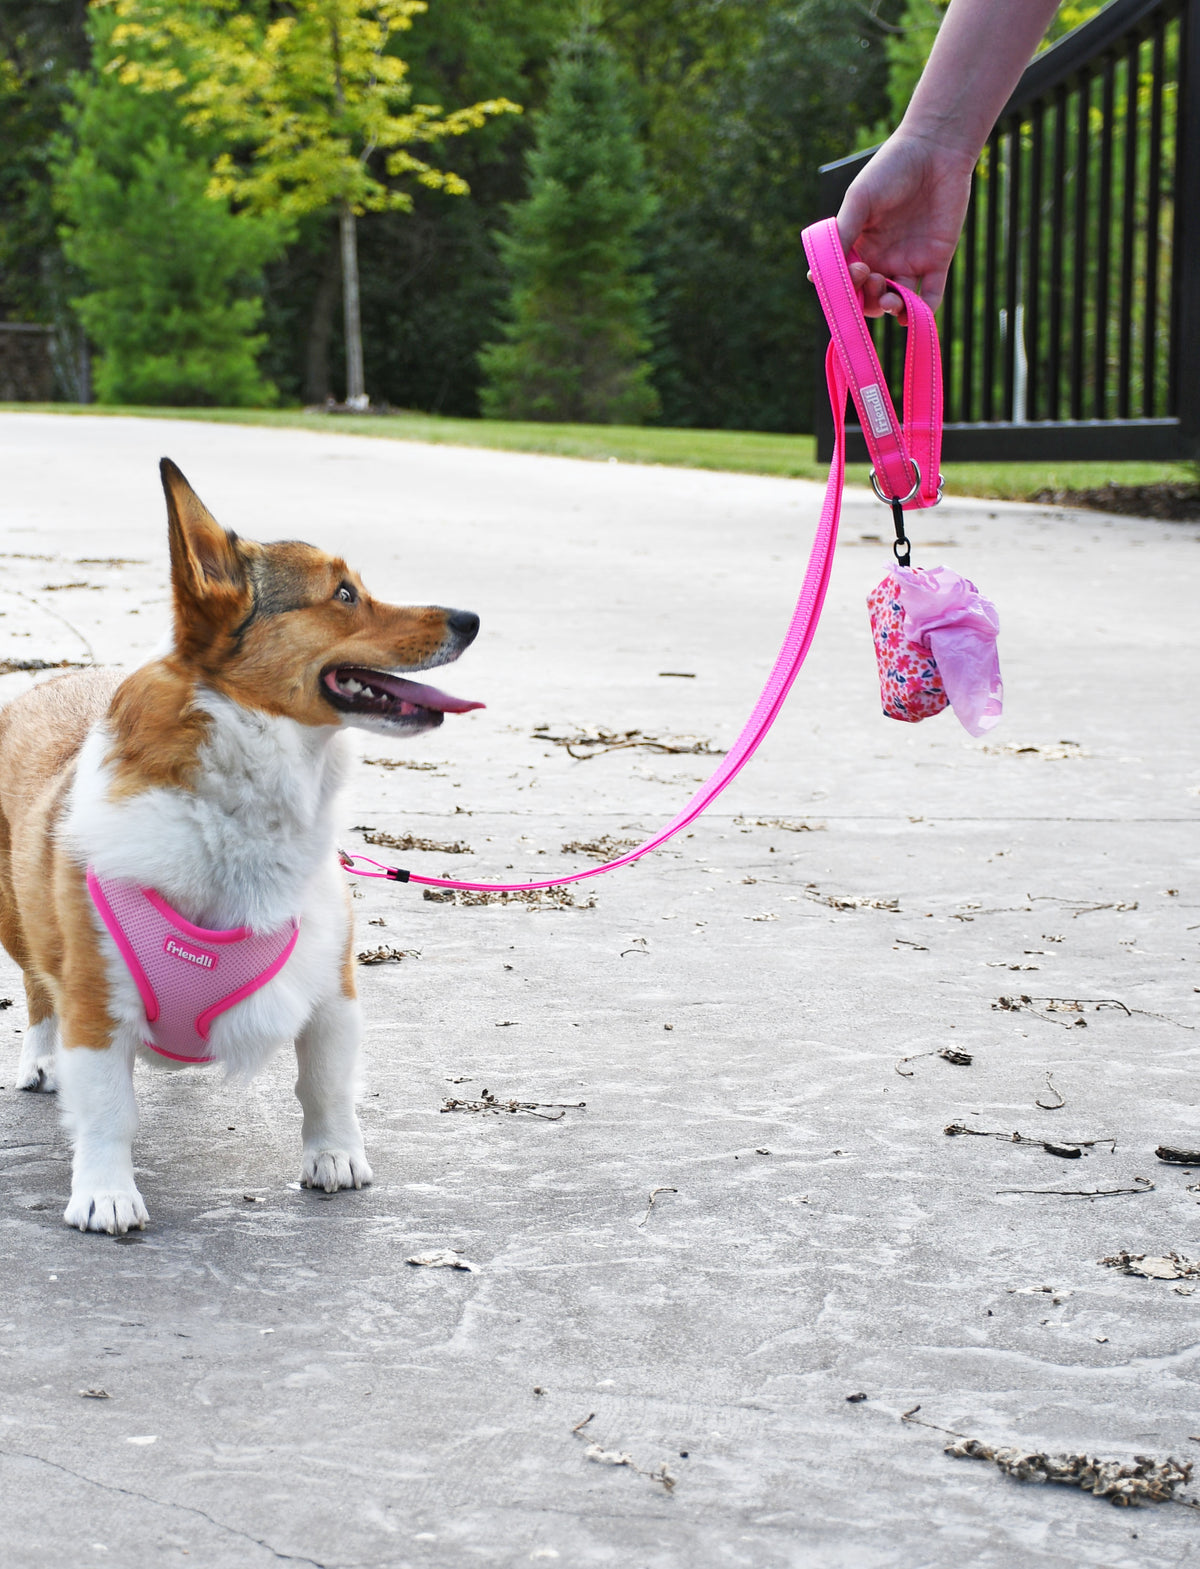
[58,1031,149,1235]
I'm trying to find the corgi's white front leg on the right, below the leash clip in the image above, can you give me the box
[296,996,372,1192]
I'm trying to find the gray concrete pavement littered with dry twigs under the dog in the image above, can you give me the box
[0,414,1200,1569]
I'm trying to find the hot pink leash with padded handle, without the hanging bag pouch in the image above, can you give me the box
[342,218,941,893]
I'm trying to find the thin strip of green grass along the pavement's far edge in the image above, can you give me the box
[0,403,1194,501]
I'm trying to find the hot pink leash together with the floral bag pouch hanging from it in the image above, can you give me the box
[340,218,1002,894]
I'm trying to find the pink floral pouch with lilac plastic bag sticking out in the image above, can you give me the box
[867,566,1004,736]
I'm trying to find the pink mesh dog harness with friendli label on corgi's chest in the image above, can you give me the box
[88,866,300,1062]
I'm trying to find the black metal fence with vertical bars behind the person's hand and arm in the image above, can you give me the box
[817,0,1200,461]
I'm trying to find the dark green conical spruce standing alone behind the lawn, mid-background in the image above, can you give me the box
[480,24,659,425]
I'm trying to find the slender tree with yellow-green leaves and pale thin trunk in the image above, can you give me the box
[94,0,518,408]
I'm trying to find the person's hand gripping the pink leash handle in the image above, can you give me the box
[838,130,976,320]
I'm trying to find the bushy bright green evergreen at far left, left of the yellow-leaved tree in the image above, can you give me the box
[56,14,284,405]
